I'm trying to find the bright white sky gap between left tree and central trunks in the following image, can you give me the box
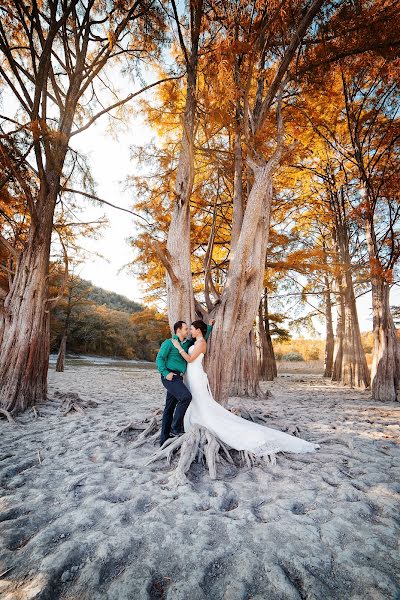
[72,117,152,302]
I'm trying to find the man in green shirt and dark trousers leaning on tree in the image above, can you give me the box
[156,321,214,446]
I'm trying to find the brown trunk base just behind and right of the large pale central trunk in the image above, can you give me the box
[230,330,264,398]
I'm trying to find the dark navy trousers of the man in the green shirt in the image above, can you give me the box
[160,373,192,445]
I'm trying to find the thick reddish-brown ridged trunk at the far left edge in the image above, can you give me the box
[0,205,55,414]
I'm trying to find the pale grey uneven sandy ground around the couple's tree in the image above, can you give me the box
[0,365,400,600]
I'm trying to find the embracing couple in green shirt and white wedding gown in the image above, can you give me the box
[156,320,319,457]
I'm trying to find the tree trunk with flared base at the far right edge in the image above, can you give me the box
[365,220,400,402]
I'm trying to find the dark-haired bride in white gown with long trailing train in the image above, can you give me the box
[172,320,319,456]
